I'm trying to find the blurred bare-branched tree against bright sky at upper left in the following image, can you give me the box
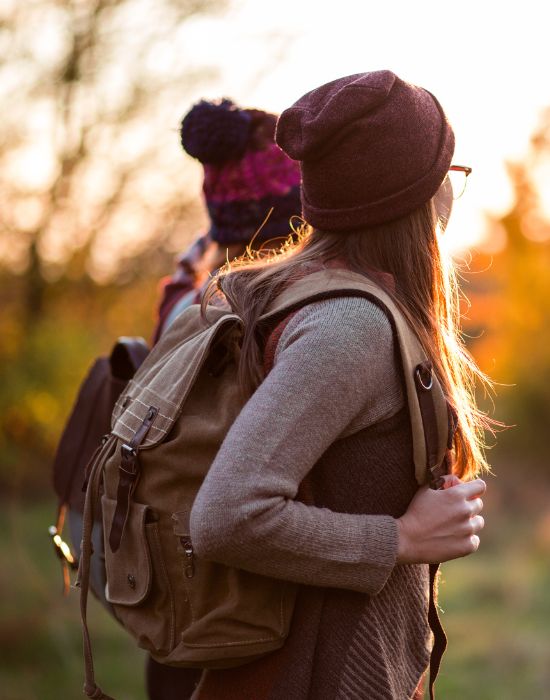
[0,0,225,320]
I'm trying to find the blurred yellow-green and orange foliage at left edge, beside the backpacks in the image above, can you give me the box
[0,270,157,495]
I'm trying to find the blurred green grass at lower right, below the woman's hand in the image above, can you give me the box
[438,506,550,700]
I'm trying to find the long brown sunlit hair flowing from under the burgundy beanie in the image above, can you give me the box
[203,200,497,478]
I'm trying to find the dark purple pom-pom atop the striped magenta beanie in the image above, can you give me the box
[180,99,251,164]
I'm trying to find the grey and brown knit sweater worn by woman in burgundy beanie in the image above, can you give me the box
[191,298,431,700]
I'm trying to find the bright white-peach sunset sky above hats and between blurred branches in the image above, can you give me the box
[0,0,550,279]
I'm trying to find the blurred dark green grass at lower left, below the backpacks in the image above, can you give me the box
[0,501,145,700]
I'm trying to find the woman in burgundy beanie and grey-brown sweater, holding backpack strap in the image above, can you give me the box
[191,71,489,700]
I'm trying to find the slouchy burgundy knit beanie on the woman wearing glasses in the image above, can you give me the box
[276,70,454,230]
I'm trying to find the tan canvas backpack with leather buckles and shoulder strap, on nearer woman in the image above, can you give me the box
[78,269,450,699]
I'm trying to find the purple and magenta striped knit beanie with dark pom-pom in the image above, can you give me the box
[180,99,301,245]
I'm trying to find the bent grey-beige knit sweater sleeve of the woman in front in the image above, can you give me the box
[191,298,402,595]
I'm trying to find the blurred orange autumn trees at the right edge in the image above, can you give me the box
[468,109,550,468]
